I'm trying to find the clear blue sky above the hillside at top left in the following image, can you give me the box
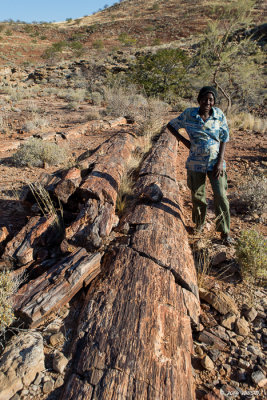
[0,0,116,22]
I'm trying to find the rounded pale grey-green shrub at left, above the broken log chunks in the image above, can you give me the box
[12,138,69,167]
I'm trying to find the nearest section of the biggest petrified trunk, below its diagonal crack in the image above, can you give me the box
[61,248,197,400]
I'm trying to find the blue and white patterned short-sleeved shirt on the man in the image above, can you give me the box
[169,107,229,172]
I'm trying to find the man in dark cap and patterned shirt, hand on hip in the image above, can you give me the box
[167,86,232,244]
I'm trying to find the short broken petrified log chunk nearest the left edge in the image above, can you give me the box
[2,214,60,265]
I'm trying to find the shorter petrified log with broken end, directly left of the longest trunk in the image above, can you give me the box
[62,133,135,251]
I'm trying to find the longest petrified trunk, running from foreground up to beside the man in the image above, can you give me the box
[61,132,199,400]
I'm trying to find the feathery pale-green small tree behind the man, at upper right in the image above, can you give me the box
[193,0,263,111]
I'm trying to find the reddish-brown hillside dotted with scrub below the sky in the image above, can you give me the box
[0,0,267,66]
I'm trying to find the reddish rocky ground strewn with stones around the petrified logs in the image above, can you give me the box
[0,64,267,400]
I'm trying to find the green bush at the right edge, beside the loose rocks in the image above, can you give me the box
[236,230,267,281]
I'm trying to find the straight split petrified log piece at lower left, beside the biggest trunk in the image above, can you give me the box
[13,249,102,328]
